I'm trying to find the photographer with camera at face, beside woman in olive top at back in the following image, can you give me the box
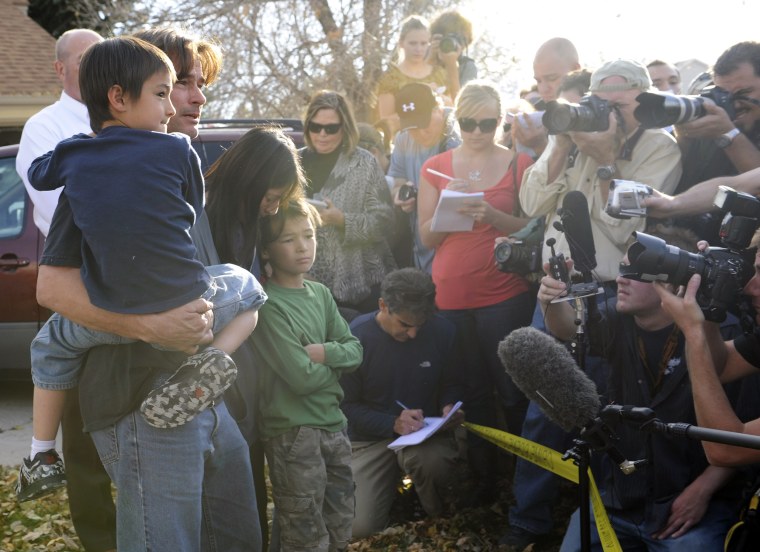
[428,10,478,103]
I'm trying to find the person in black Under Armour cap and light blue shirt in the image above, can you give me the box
[388,83,462,274]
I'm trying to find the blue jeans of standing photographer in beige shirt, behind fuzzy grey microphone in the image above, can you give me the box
[509,295,609,535]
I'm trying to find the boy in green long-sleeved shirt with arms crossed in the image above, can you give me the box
[252,200,362,552]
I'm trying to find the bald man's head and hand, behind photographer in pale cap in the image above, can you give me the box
[512,37,581,157]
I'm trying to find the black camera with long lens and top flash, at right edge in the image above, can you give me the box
[620,186,760,322]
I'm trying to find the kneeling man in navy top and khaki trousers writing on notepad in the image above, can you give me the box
[340,268,463,538]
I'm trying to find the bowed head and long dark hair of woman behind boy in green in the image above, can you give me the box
[206,127,304,277]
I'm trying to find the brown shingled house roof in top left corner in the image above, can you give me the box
[0,0,61,96]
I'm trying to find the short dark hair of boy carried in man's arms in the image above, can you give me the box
[79,36,175,132]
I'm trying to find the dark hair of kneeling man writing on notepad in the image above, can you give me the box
[380,268,436,320]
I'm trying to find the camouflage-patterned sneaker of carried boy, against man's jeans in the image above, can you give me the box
[140,347,237,429]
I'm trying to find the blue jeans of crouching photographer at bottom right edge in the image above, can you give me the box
[560,500,738,552]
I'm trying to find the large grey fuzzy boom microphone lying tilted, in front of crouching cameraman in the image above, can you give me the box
[498,327,600,432]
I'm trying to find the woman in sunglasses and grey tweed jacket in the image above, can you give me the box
[300,90,396,313]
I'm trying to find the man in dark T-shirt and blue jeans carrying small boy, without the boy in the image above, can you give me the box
[38,29,261,550]
